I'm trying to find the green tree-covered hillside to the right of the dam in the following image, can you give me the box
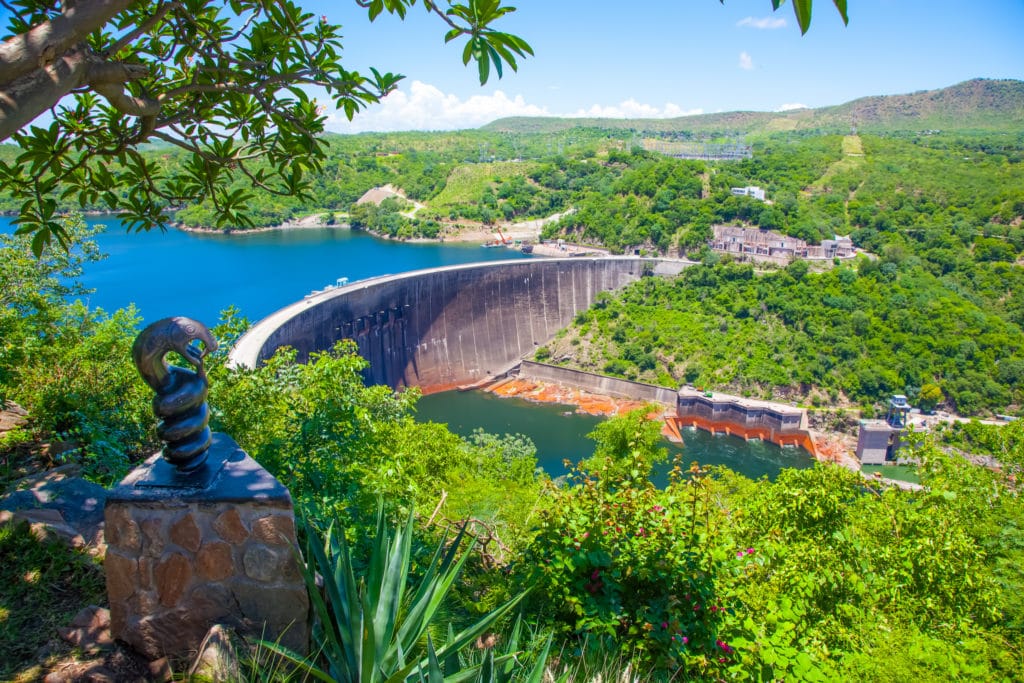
[538,131,1024,415]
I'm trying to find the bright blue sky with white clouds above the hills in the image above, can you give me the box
[313,0,1024,132]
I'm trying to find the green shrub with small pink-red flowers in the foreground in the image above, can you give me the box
[522,411,737,674]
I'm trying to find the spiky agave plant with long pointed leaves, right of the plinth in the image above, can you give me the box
[263,503,550,683]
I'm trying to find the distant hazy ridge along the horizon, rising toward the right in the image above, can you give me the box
[482,79,1024,134]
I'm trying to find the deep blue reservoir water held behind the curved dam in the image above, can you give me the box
[0,216,528,327]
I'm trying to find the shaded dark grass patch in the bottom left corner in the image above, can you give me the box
[0,524,106,681]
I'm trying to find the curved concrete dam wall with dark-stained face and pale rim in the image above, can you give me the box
[230,257,691,392]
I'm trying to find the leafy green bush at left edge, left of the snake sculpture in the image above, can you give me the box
[0,218,157,484]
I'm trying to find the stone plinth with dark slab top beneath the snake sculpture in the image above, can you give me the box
[105,434,309,658]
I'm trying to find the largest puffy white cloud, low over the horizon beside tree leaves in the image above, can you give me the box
[326,81,551,133]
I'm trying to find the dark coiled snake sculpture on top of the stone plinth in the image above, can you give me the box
[131,316,217,472]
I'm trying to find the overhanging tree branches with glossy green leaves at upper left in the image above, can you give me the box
[0,0,532,254]
